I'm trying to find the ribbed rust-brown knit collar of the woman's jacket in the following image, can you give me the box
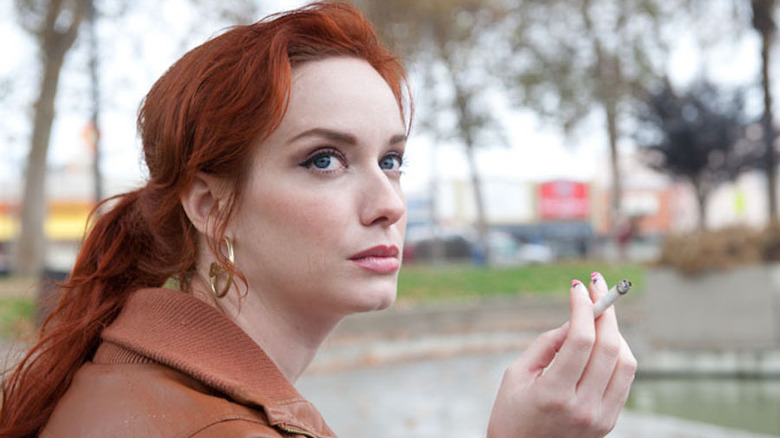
[96,289,335,438]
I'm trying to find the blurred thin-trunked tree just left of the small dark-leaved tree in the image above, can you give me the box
[504,0,671,231]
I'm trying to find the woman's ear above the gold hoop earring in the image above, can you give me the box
[181,172,228,236]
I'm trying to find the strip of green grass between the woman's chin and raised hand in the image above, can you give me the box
[398,262,644,301]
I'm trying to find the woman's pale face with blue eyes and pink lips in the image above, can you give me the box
[229,57,406,318]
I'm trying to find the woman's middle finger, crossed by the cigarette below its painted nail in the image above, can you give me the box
[577,272,622,400]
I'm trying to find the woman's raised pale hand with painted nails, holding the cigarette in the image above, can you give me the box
[488,272,636,438]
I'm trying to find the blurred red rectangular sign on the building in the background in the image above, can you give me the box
[539,180,590,220]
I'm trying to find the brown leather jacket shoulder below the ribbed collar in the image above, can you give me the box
[40,363,281,438]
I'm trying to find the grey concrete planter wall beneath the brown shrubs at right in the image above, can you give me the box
[646,265,780,350]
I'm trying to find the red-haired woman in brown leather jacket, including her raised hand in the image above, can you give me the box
[0,3,636,437]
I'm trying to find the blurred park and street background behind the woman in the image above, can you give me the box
[0,0,780,437]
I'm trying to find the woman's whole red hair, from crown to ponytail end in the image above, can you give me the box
[0,2,411,437]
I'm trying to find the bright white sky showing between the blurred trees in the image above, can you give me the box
[0,0,759,202]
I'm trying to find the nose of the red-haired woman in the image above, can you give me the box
[360,169,406,227]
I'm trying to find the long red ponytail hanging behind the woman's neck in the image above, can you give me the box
[0,189,194,437]
